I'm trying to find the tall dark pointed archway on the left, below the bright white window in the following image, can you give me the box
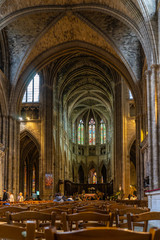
[19,132,39,199]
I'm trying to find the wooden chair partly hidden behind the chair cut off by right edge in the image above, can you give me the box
[115,207,150,228]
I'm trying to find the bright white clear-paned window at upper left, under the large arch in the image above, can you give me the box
[22,74,40,103]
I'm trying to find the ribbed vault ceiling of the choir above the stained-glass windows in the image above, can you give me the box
[56,53,119,123]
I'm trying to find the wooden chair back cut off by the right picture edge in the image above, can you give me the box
[127,212,160,232]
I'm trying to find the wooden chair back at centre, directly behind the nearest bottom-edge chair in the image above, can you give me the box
[62,212,113,231]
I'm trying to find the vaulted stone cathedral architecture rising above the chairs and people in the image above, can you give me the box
[0,0,160,199]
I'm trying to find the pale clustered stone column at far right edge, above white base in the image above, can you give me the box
[146,65,160,189]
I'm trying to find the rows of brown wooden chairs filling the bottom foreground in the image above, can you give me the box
[0,201,160,240]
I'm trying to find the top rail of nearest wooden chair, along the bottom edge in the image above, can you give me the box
[45,228,160,240]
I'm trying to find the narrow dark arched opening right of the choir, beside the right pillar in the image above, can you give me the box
[130,140,137,186]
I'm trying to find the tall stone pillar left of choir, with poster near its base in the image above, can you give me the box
[39,67,54,199]
